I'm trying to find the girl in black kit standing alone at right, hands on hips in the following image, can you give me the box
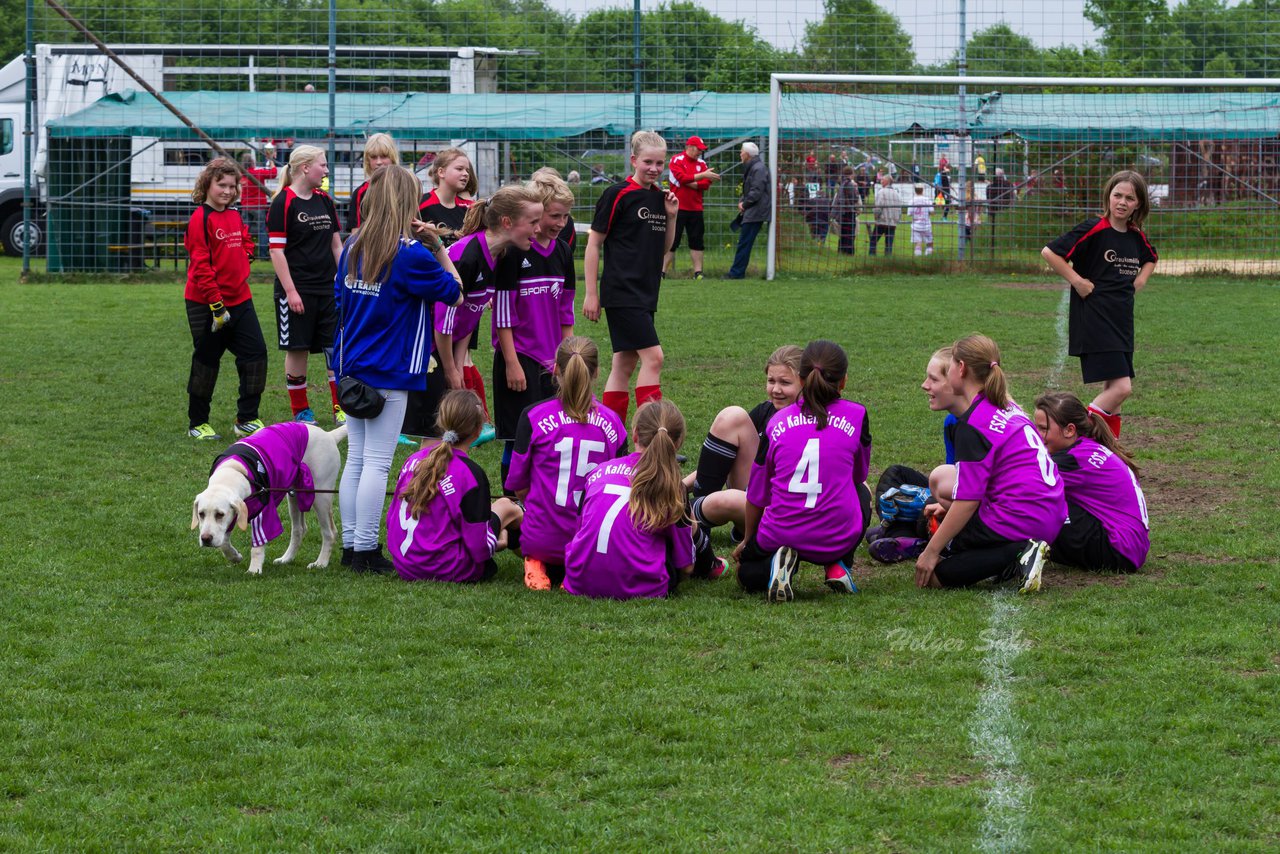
[1041,170,1157,438]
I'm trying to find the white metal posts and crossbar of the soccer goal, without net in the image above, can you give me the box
[765,73,1280,282]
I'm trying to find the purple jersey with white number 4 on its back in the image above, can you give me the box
[746,399,872,563]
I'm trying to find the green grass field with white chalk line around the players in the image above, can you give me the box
[0,261,1280,851]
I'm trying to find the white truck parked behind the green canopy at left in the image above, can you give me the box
[0,44,514,255]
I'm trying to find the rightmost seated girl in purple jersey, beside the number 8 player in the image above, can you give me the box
[1036,392,1151,572]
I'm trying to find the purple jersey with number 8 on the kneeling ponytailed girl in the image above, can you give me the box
[955,393,1066,543]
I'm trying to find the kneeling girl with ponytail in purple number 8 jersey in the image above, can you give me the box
[915,335,1066,592]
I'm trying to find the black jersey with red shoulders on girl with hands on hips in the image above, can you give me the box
[1048,216,1157,356]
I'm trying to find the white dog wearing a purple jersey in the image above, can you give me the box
[191,421,347,575]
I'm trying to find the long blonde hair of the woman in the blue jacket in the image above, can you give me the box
[347,165,417,282]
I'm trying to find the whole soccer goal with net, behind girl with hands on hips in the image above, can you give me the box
[767,74,1280,279]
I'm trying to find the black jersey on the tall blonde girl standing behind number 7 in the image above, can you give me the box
[591,178,667,311]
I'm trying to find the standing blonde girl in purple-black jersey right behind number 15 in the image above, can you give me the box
[493,169,576,494]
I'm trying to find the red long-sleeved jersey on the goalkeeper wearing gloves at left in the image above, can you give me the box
[183,205,253,306]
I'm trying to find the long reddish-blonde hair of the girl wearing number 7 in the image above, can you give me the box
[627,401,689,533]
